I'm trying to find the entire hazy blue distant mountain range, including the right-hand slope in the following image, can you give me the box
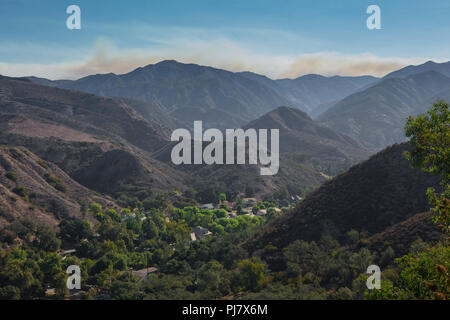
[29,60,450,153]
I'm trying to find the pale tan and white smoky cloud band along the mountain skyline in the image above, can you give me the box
[0,28,442,79]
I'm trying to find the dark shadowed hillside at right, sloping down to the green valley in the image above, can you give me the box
[247,144,439,249]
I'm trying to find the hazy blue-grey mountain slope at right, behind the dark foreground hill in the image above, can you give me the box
[317,71,450,152]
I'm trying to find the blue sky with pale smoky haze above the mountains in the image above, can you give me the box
[0,0,450,78]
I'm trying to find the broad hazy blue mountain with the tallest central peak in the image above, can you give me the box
[29,60,289,128]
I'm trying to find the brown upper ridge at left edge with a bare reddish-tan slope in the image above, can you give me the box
[0,75,169,152]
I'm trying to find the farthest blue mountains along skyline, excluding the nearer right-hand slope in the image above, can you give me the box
[29,60,377,129]
